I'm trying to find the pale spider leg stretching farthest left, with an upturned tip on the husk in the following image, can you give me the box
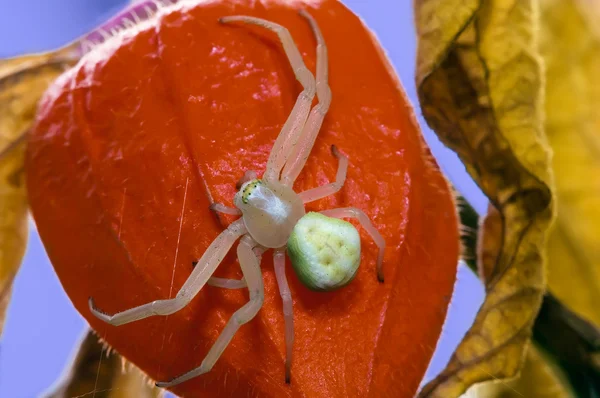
[89,220,246,326]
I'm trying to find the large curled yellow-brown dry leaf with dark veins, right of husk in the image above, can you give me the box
[415,0,553,398]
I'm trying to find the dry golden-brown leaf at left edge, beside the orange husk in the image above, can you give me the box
[0,42,79,333]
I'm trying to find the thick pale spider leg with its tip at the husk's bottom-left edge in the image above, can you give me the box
[156,235,264,387]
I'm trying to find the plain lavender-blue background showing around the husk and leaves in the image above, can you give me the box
[0,0,486,398]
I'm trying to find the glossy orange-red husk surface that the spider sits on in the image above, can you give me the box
[26,0,459,397]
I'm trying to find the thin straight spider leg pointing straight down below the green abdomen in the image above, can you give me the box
[273,250,294,384]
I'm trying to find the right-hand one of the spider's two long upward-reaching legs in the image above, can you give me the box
[281,11,331,186]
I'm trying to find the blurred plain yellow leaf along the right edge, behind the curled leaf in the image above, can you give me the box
[541,0,600,327]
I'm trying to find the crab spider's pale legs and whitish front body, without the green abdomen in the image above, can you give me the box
[89,11,385,387]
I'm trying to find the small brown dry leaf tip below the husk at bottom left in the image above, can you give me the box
[46,331,163,398]
